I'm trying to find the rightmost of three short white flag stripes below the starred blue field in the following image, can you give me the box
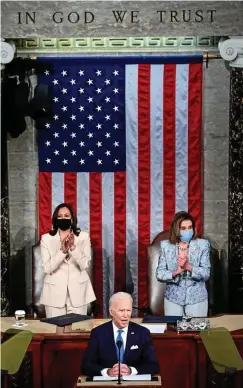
[102,172,115,317]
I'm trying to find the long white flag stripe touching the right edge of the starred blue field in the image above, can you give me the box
[125,65,138,306]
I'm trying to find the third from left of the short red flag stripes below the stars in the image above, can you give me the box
[89,172,103,317]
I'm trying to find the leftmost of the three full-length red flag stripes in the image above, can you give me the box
[138,65,151,306]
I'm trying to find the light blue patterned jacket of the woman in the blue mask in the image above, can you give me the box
[156,238,210,306]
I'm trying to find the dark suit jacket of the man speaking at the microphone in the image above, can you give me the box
[82,321,159,376]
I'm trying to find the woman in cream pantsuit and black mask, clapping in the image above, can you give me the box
[40,203,96,318]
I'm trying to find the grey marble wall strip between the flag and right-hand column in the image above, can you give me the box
[203,60,230,249]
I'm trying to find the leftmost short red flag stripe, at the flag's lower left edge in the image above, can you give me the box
[38,172,52,238]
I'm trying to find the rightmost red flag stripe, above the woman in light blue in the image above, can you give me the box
[188,64,202,234]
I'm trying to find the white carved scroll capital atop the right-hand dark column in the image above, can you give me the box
[218,36,243,68]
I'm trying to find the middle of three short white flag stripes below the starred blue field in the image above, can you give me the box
[77,172,90,233]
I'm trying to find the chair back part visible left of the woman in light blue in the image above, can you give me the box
[147,231,169,315]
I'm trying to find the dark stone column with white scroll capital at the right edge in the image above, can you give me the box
[219,37,243,313]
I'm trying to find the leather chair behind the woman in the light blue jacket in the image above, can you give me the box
[146,231,220,316]
